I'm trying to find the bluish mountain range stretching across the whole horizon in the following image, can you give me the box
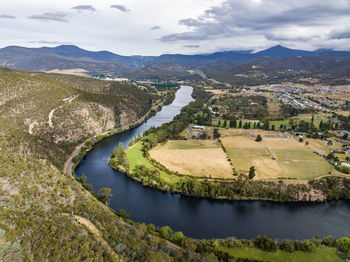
[0,45,350,83]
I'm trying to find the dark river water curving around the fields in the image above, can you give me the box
[76,86,350,239]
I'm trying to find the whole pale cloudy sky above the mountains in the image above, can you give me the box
[0,0,350,55]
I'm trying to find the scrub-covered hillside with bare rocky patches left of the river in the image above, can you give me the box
[0,68,178,261]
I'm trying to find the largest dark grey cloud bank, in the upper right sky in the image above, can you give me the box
[159,0,350,42]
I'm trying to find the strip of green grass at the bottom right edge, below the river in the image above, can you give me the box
[220,246,343,262]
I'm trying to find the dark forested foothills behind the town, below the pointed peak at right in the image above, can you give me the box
[200,53,350,85]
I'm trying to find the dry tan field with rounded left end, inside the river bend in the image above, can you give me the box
[150,140,233,178]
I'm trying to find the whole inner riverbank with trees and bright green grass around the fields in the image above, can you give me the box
[110,91,350,202]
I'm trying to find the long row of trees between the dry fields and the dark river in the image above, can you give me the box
[117,159,350,202]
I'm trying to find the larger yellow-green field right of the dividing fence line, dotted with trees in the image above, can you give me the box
[221,129,338,179]
